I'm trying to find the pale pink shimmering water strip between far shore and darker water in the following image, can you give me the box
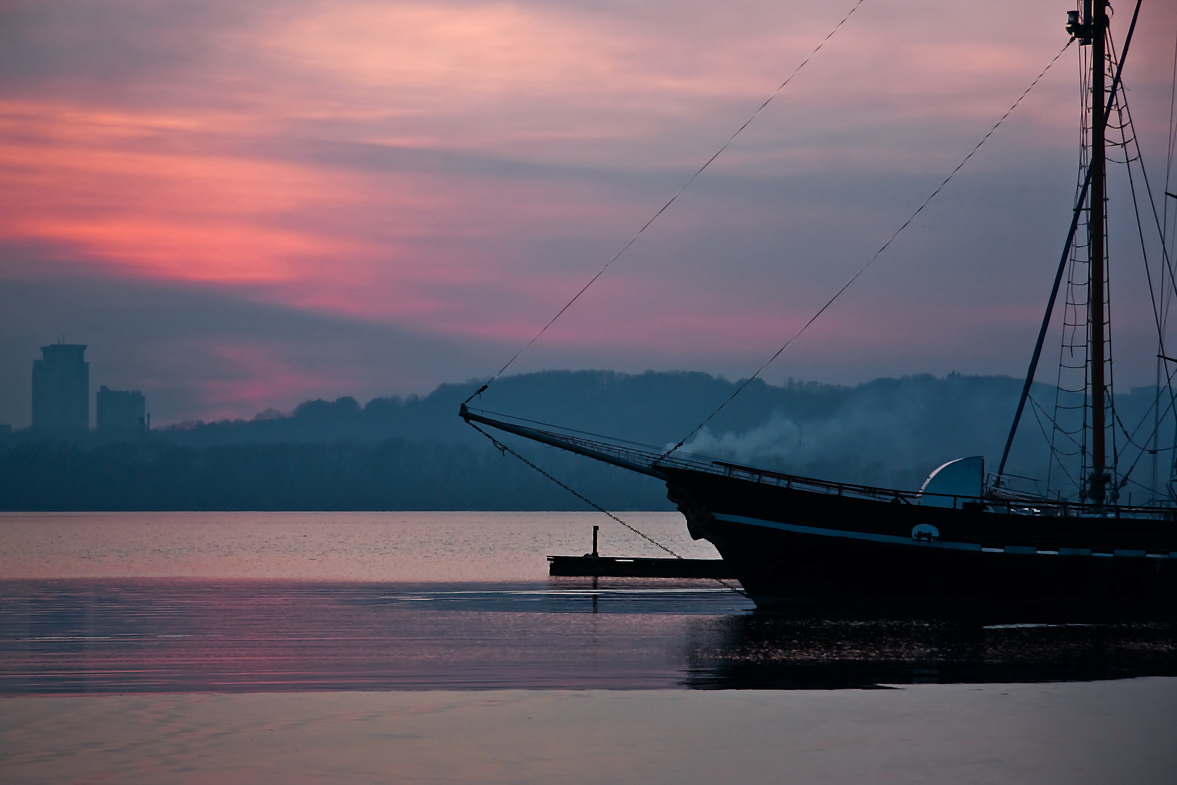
[0,512,716,583]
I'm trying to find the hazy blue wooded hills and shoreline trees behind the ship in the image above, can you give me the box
[0,371,1149,511]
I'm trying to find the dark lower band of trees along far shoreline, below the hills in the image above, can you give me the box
[0,439,667,511]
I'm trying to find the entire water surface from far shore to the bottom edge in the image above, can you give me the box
[0,513,1177,784]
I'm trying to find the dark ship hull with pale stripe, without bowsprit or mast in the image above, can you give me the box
[663,467,1177,619]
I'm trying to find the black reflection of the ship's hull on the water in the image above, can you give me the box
[686,614,1177,690]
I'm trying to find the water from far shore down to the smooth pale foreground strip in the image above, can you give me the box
[0,513,1177,696]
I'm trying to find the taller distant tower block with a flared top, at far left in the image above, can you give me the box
[33,344,89,437]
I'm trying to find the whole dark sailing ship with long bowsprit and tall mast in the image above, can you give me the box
[460,0,1177,617]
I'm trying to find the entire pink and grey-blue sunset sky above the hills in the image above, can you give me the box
[0,0,1177,427]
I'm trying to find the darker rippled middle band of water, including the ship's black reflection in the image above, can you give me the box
[0,579,1177,696]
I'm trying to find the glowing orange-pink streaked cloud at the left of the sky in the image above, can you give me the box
[0,97,473,297]
